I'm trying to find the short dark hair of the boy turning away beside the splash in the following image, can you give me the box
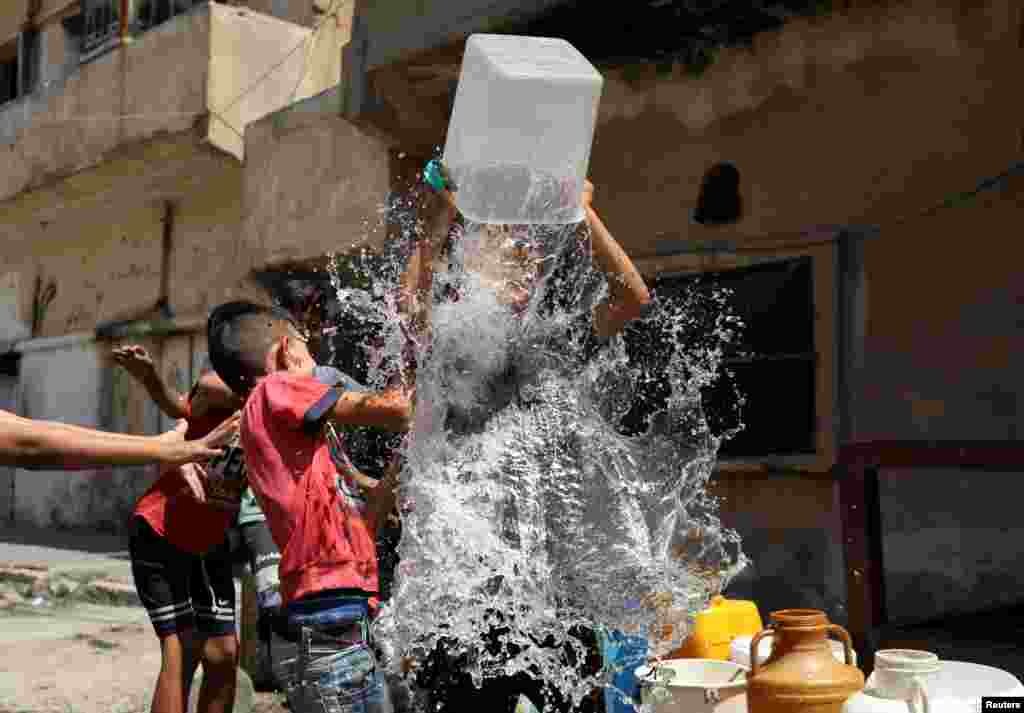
[207,301,301,394]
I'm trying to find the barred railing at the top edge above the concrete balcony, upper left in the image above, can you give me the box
[81,0,207,61]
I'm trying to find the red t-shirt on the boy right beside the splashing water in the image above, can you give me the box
[241,368,377,606]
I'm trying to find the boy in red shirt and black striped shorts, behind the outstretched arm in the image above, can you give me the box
[114,346,245,713]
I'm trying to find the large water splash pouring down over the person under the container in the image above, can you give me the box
[319,186,745,703]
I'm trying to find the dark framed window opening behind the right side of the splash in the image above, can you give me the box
[624,258,816,458]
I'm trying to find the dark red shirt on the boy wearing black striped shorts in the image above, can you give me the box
[135,387,238,554]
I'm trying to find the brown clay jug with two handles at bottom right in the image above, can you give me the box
[746,610,864,713]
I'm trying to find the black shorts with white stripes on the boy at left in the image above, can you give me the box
[129,516,234,638]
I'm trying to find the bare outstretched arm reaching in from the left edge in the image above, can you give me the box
[0,411,239,468]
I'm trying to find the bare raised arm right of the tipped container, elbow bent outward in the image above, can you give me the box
[583,180,650,338]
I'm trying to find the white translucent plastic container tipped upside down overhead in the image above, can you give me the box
[444,35,604,224]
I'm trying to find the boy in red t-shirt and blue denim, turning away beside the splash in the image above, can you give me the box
[209,302,412,713]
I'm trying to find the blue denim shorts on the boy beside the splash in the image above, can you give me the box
[278,596,392,713]
